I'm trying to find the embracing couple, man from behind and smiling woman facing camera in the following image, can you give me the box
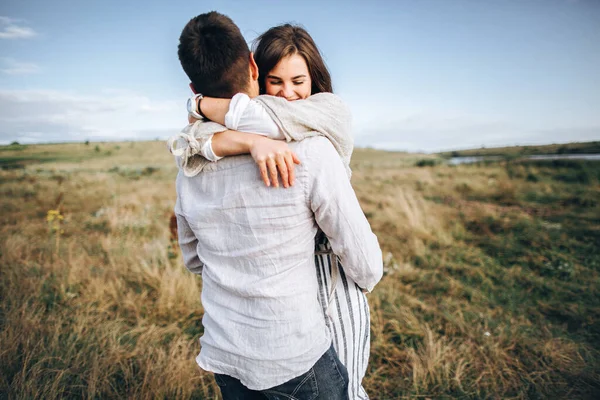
[169,12,382,400]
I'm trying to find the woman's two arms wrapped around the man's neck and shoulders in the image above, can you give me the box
[185,93,353,186]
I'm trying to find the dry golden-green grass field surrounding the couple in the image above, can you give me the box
[0,142,600,399]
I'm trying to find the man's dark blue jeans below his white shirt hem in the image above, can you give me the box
[215,346,348,400]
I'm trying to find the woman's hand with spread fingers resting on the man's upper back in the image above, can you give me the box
[250,135,300,188]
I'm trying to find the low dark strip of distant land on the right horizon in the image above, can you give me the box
[439,141,600,157]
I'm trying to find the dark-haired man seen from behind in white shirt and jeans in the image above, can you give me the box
[175,12,382,399]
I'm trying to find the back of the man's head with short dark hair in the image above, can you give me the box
[177,11,250,98]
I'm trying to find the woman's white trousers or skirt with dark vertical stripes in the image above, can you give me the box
[315,232,370,399]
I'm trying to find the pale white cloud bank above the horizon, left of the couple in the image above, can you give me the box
[0,90,187,143]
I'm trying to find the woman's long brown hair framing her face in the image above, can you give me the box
[253,24,333,94]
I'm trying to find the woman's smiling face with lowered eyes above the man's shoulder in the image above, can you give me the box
[265,53,312,101]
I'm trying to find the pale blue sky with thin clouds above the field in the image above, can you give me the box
[0,0,600,152]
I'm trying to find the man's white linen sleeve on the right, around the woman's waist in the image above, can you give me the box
[307,138,383,292]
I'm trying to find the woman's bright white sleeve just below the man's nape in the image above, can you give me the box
[225,93,285,140]
